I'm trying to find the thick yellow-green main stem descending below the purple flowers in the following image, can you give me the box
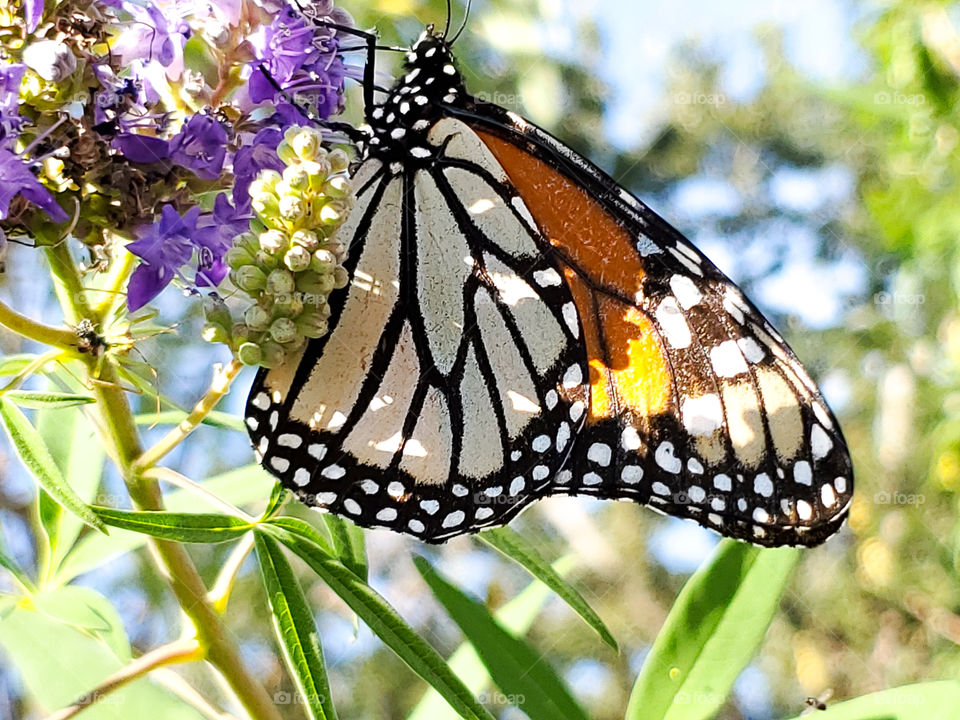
[47,243,280,720]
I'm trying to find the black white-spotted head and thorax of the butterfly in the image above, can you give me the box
[366,27,466,174]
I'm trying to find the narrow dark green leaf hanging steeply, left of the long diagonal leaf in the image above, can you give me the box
[253,531,337,720]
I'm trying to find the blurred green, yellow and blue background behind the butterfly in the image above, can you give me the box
[0,0,960,720]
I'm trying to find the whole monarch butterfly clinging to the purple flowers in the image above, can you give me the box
[246,12,853,546]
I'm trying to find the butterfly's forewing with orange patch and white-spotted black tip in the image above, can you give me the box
[454,105,853,545]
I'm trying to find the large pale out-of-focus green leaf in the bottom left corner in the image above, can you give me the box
[0,587,202,720]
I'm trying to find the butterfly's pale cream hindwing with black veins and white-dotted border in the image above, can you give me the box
[247,132,587,541]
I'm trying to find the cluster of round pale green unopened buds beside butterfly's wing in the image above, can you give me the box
[207,127,353,367]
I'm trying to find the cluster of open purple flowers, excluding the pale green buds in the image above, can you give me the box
[0,0,356,310]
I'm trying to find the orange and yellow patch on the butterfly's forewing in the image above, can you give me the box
[477,131,673,422]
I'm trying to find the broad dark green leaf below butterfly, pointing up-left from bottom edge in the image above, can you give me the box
[413,557,587,720]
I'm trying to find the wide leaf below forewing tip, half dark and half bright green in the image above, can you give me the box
[626,540,801,720]
